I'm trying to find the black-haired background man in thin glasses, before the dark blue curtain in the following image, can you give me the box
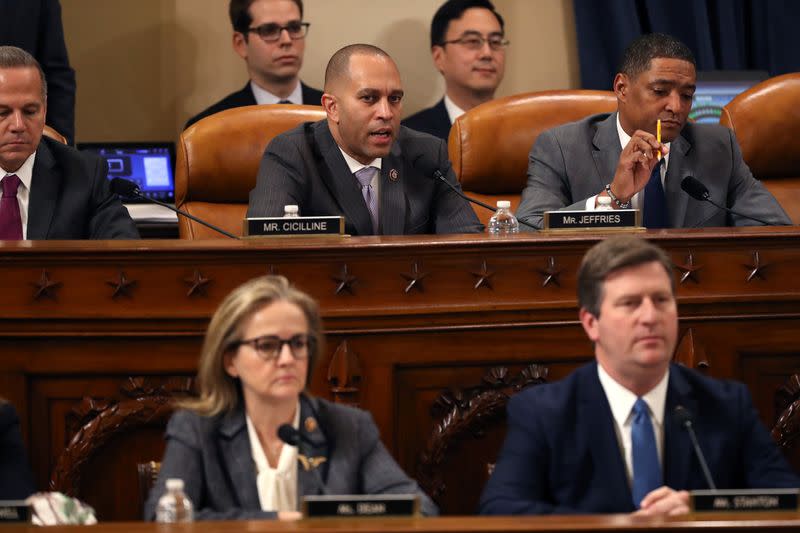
[403,0,508,142]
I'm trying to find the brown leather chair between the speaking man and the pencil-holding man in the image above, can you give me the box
[448,90,617,224]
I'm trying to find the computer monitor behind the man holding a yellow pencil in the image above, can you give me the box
[689,70,769,124]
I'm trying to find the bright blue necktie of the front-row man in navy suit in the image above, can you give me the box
[631,398,664,509]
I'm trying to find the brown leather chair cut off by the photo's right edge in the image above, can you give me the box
[720,72,800,224]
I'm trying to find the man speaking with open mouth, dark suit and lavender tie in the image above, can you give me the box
[247,44,482,235]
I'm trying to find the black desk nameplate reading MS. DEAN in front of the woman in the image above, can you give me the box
[303,494,420,518]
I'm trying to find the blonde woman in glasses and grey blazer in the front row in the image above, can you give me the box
[145,276,437,520]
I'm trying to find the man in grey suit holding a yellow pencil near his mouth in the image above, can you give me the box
[517,33,791,228]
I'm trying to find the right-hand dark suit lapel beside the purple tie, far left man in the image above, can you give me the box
[27,140,61,240]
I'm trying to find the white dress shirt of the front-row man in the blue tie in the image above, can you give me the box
[597,363,669,485]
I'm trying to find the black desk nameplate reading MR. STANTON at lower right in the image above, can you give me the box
[689,489,800,513]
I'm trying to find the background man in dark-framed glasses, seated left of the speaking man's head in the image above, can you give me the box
[186,0,322,128]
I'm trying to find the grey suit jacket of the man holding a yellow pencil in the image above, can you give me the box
[517,113,792,228]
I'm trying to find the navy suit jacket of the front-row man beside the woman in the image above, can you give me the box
[480,363,800,514]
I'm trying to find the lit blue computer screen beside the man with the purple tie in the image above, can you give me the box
[78,142,175,203]
